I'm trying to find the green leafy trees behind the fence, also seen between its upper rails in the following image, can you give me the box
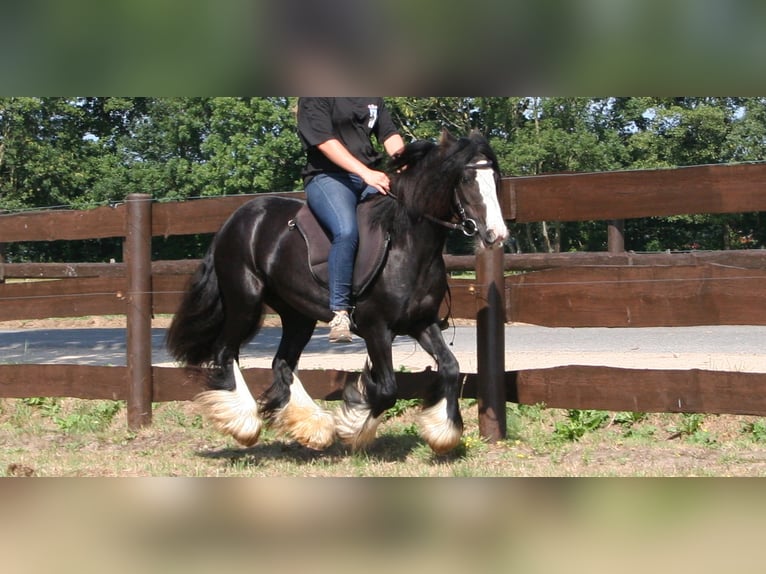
[0,97,766,261]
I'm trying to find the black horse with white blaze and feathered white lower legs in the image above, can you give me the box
[167,131,507,453]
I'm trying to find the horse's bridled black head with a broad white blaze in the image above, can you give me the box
[439,130,508,247]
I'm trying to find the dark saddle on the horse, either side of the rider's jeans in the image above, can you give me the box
[288,202,391,297]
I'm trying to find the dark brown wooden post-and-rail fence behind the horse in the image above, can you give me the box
[0,164,766,440]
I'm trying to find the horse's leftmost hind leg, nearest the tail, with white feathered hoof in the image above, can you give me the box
[195,274,263,446]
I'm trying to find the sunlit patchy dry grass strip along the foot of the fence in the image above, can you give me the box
[0,397,766,477]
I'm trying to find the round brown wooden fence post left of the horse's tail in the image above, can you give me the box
[124,193,153,430]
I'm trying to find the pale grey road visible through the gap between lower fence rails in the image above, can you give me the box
[0,317,766,372]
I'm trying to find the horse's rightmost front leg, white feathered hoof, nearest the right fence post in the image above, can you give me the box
[415,323,463,454]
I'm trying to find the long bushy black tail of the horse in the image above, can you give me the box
[165,245,224,365]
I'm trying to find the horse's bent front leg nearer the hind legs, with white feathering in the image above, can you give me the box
[335,331,396,451]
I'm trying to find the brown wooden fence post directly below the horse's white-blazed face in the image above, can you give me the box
[476,247,506,442]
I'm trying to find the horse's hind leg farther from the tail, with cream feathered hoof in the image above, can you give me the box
[259,313,335,450]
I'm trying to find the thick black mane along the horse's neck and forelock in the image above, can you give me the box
[370,131,498,233]
